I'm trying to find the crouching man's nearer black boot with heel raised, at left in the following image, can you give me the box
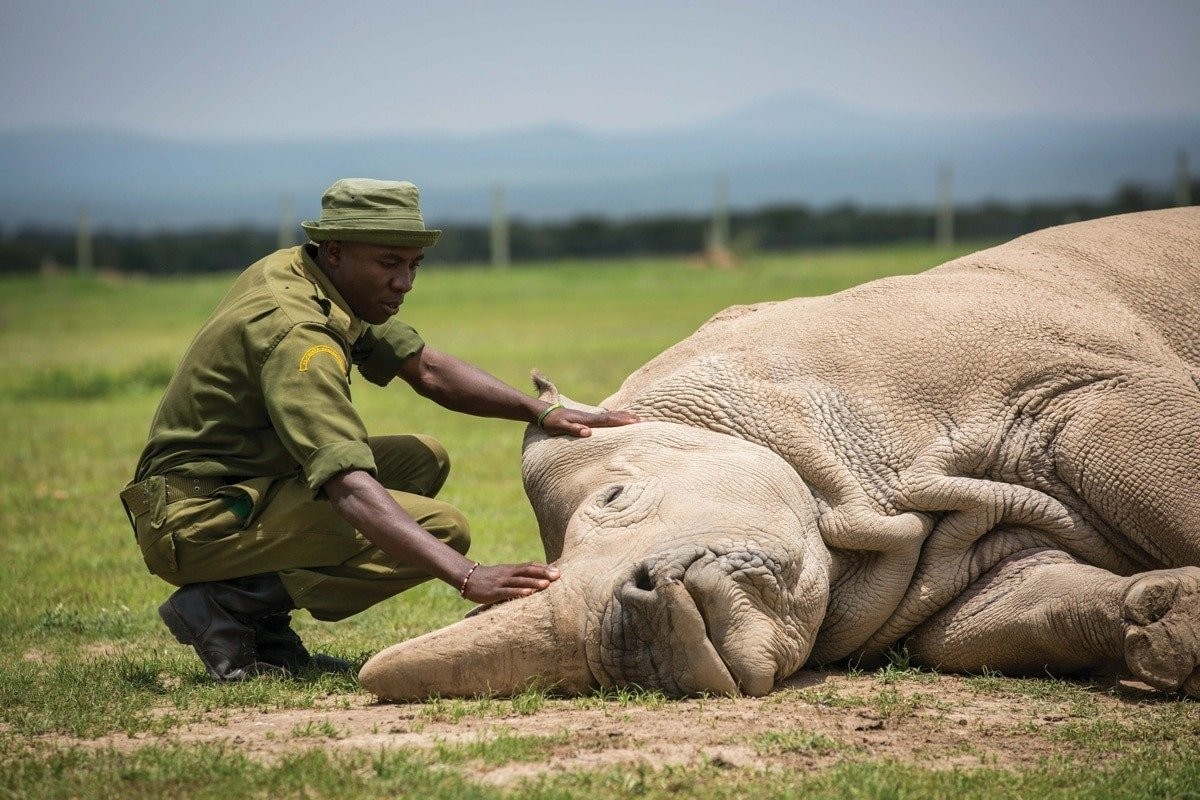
[158,575,295,680]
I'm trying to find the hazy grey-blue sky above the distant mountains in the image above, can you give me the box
[0,0,1200,140]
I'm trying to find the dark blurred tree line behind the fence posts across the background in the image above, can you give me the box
[0,181,1200,275]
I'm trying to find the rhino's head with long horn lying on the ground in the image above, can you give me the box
[360,387,829,699]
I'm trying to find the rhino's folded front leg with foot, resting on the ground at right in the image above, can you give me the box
[906,549,1200,697]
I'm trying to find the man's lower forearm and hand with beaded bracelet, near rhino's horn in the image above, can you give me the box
[324,470,559,603]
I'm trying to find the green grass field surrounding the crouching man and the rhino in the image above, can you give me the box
[0,246,1200,798]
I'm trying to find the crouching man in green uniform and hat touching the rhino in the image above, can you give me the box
[121,179,636,680]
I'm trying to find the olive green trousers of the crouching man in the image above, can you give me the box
[133,435,470,620]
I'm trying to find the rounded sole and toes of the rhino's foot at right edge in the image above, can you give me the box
[1122,567,1200,698]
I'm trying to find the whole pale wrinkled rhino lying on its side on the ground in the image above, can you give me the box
[361,207,1200,699]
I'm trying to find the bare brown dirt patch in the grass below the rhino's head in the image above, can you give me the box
[28,672,1180,784]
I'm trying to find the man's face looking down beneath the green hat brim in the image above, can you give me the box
[323,241,425,325]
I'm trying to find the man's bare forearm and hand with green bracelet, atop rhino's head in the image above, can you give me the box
[400,345,638,437]
